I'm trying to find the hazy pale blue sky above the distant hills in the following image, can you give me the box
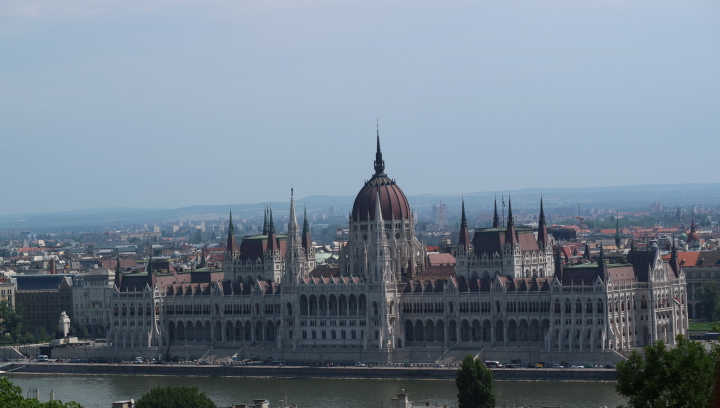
[0,0,720,214]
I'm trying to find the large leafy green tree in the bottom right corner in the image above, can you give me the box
[616,335,720,408]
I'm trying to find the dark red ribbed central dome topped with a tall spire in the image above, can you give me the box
[352,134,410,221]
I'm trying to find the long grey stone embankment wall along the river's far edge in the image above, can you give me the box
[4,362,616,381]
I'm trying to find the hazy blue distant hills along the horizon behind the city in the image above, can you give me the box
[0,183,720,231]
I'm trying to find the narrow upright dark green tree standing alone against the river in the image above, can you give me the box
[455,354,495,408]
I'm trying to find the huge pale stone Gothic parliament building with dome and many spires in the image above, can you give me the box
[108,131,688,363]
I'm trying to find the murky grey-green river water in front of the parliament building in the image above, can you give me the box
[8,373,625,408]
